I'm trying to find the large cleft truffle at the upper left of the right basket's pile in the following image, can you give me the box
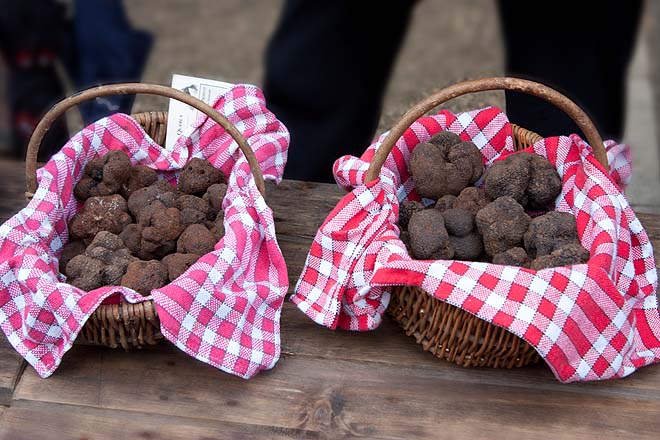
[410,138,483,200]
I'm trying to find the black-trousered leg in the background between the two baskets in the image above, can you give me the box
[264,0,415,182]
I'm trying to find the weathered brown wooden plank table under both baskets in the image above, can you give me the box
[0,161,660,440]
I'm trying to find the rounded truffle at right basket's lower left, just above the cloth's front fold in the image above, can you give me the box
[408,209,454,260]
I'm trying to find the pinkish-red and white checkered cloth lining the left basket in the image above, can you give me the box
[0,85,289,378]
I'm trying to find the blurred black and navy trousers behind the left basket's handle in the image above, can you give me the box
[0,0,152,161]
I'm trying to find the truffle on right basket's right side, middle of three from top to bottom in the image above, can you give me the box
[524,211,579,258]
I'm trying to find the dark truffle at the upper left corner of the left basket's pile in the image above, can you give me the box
[73,150,131,201]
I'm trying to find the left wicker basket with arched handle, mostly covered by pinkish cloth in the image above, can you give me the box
[25,83,265,350]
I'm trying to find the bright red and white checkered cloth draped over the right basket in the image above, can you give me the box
[292,108,660,382]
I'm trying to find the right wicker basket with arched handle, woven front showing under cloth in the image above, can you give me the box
[366,78,608,368]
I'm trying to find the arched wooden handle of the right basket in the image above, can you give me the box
[365,78,609,182]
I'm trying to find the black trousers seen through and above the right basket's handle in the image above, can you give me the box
[499,0,642,140]
